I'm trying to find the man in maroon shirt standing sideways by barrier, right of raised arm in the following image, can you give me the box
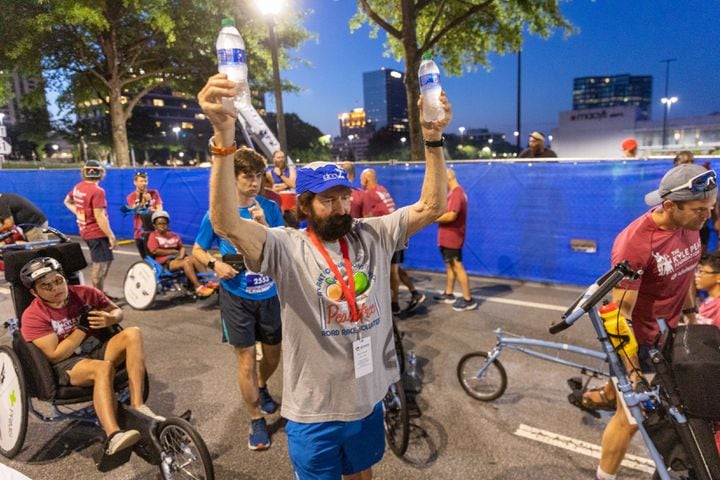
[435,168,478,312]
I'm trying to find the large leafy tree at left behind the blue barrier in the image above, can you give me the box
[0,0,310,165]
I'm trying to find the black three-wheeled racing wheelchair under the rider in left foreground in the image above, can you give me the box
[0,232,214,480]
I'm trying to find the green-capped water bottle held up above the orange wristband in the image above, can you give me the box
[215,18,250,111]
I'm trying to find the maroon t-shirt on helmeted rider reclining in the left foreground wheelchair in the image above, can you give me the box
[20,285,110,342]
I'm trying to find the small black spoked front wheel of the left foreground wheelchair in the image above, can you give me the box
[158,417,215,480]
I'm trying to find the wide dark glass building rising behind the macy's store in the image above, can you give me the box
[573,74,652,120]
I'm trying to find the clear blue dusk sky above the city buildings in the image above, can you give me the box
[278,0,720,141]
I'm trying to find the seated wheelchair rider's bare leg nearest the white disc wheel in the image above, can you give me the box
[68,359,120,436]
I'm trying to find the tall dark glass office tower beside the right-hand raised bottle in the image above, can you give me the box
[363,68,408,132]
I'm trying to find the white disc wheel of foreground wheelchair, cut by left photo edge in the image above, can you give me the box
[0,346,28,458]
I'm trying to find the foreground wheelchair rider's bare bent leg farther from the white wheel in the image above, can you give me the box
[105,327,145,408]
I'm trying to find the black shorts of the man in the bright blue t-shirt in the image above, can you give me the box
[220,286,282,348]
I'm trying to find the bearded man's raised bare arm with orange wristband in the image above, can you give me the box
[198,73,267,261]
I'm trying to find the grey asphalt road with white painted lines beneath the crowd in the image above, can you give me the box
[0,242,651,480]
